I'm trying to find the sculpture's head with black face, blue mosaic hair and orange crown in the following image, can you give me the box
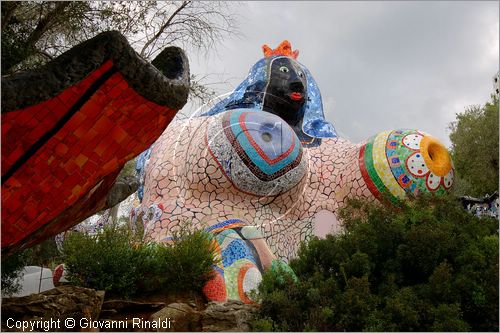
[201,40,337,146]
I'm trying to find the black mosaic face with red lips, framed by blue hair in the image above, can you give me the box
[263,58,307,126]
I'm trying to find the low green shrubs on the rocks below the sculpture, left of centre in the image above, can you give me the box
[63,227,215,297]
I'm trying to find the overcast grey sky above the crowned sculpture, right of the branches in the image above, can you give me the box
[187,1,499,147]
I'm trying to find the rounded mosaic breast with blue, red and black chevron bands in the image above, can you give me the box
[206,109,307,196]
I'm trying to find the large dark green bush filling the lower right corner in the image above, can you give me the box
[253,196,498,331]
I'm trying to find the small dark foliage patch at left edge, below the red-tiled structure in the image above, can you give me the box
[2,251,29,296]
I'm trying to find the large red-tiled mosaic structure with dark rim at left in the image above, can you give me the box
[2,32,189,254]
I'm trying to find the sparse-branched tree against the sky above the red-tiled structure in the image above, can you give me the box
[1,1,237,99]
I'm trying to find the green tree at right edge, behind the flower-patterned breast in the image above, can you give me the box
[450,97,499,197]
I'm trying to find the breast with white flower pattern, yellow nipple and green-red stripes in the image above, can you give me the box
[359,130,454,202]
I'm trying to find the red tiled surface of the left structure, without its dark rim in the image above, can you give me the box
[2,56,180,249]
